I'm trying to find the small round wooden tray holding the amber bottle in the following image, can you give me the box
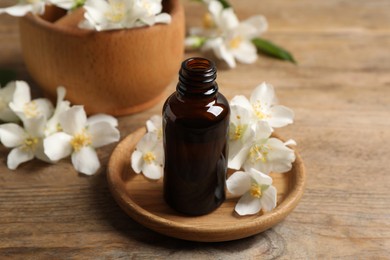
[107,128,305,242]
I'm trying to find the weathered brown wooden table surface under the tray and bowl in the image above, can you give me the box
[0,0,390,259]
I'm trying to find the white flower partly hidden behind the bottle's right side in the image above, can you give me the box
[228,106,255,170]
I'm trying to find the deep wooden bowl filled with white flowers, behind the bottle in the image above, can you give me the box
[19,0,185,116]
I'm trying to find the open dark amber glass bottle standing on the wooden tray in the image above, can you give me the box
[163,58,230,215]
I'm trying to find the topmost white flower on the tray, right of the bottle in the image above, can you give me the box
[230,82,294,128]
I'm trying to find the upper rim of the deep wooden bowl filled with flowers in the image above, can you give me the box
[21,0,184,37]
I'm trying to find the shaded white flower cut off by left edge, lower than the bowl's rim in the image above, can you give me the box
[0,81,19,122]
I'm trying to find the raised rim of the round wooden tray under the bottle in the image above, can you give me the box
[107,127,306,242]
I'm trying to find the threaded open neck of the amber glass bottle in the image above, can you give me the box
[176,58,218,97]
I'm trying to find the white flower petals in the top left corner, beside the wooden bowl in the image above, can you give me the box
[0,0,47,17]
